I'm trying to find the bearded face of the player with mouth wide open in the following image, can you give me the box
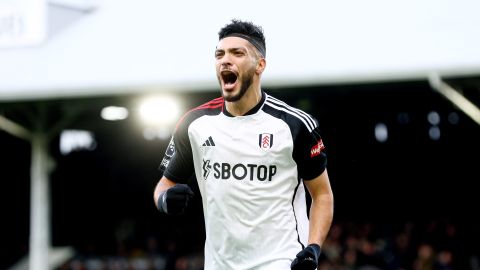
[215,37,257,102]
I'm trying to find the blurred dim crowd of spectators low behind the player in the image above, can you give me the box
[60,219,480,270]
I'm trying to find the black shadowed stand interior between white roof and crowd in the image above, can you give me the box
[0,78,480,269]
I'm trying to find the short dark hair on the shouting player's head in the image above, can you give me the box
[218,19,266,57]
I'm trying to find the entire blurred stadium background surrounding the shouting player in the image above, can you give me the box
[0,0,480,270]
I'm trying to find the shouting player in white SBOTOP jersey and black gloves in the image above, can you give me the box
[154,20,333,270]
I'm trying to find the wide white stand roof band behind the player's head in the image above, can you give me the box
[0,0,480,100]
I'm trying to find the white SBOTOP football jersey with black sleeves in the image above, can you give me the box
[160,92,326,270]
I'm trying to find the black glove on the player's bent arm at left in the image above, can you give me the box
[157,184,194,215]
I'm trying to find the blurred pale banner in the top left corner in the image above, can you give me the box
[0,0,47,48]
